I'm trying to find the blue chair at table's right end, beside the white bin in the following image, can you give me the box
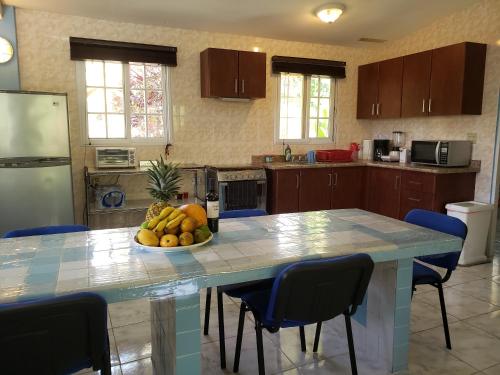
[405,209,467,349]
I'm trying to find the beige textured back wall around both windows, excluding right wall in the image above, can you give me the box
[17,9,368,223]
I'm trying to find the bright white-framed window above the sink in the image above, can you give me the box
[276,73,336,143]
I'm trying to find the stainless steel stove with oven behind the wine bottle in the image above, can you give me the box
[205,165,267,216]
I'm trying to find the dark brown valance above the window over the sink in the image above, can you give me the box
[271,56,346,78]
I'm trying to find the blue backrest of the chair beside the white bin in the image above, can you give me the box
[405,209,467,271]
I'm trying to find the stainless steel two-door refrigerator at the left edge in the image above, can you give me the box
[0,91,74,236]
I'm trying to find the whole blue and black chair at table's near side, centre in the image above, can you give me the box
[233,254,374,375]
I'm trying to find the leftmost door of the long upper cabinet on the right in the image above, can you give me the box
[356,63,378,119]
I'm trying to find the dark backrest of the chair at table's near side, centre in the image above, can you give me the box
[266,254,373,325]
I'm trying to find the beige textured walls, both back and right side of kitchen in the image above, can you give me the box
[12,0,500,223]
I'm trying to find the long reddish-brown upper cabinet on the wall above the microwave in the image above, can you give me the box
[357,42,486,119]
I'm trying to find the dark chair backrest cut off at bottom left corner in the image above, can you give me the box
[0,293,109,375]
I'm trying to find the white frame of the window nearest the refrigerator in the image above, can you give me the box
[76,60,173,147]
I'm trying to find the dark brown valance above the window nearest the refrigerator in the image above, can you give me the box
[69,37,177,66]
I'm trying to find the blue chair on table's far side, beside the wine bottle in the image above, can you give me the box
[203,210,273,369]
